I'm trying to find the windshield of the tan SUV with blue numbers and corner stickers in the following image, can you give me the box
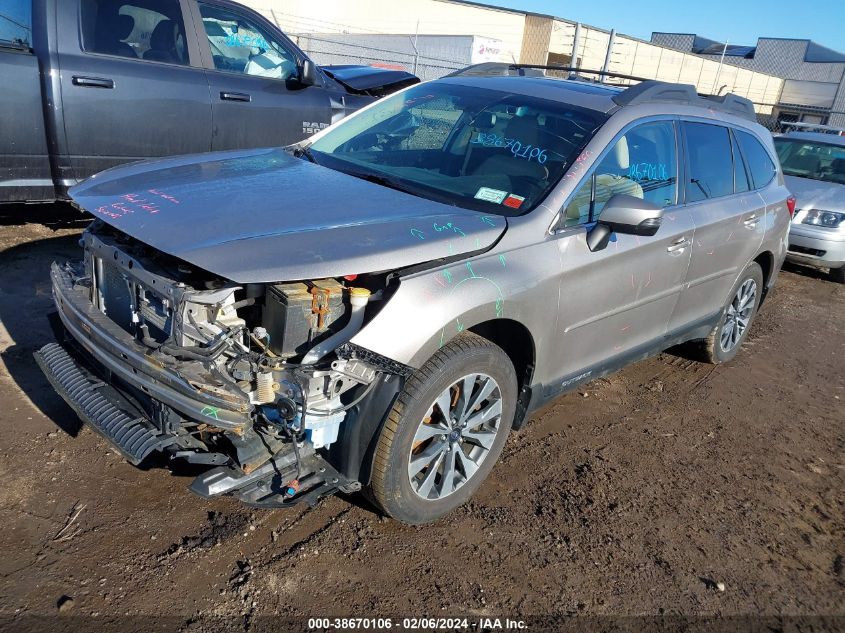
[309,81,606,216]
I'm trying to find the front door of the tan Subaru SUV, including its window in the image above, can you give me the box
[555,120,694,382]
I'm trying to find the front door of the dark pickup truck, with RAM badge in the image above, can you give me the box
[194,2,332,151]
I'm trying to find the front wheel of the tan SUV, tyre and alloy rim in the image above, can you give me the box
[370,332,517,524]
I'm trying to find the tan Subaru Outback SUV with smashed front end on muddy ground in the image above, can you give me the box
[37,66,794,523]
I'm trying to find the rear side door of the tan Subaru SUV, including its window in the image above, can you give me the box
[669,121,766,331]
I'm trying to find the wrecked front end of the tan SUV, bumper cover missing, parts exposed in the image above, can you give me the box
[36,223,411,507]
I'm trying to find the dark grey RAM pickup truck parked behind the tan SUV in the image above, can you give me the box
[0,0,419,202]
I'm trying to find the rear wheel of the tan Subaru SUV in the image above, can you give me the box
[703,262,763,365]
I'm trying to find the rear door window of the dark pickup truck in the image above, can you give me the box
[82,0,188,65]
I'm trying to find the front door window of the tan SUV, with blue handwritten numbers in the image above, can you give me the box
[565,121,678,226]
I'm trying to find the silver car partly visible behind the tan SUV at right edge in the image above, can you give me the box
[775,132,845,283]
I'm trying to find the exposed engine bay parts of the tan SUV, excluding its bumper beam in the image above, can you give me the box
[74,222,395,495]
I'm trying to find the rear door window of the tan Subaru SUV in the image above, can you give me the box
[683,122,734,202]
